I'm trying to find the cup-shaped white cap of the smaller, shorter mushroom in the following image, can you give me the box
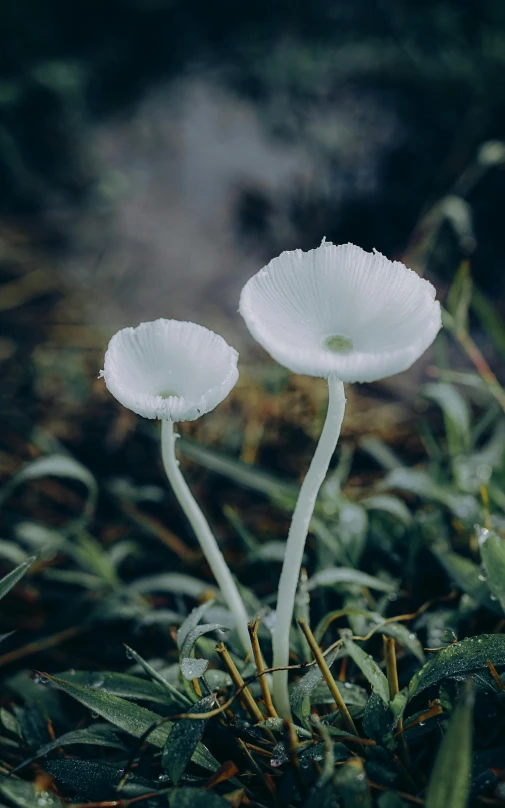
[100,319,238,422]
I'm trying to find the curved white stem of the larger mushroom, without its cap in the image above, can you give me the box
[273,377,345,718]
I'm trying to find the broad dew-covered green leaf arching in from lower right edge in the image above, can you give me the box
[408,634,505,700]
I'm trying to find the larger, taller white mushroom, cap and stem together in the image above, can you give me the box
[240,241,441,717]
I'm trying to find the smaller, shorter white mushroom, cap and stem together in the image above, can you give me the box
[100,319,251,652]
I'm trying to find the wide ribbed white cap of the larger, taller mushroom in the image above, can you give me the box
[239,241,442,382]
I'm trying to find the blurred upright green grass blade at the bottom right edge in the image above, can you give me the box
[425,687,474,808]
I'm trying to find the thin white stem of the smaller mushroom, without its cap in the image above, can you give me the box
[161,421,252,658]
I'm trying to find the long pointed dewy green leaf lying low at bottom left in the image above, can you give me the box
[46,674,219,771]
